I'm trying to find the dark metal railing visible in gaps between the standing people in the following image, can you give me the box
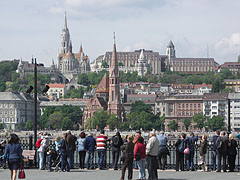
[20,140,240,170]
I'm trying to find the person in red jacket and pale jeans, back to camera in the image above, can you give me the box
[134,137,146,179]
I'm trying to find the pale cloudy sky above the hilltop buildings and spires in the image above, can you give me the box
[0,0,240,66]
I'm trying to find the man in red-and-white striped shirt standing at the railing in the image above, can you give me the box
[96,130,108,170]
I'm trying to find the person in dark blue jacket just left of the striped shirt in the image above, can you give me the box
[83,133,96,169]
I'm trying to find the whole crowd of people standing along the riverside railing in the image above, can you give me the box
[0,130,237,180]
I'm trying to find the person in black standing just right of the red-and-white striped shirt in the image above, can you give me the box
[112,132,123,170]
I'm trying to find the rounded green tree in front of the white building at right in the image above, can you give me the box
[206,116,225,131]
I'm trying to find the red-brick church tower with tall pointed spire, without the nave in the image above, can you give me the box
[108,36,121,118]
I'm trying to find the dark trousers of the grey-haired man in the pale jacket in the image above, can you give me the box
[147,155,158,180]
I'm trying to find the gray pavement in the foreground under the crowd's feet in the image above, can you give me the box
[0,169,240,180]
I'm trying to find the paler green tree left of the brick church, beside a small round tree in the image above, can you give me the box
[48,111,64,129]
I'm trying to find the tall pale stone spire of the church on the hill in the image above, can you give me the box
[61,11,70,54]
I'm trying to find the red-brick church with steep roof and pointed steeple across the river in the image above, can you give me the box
[82,39,123,129]
